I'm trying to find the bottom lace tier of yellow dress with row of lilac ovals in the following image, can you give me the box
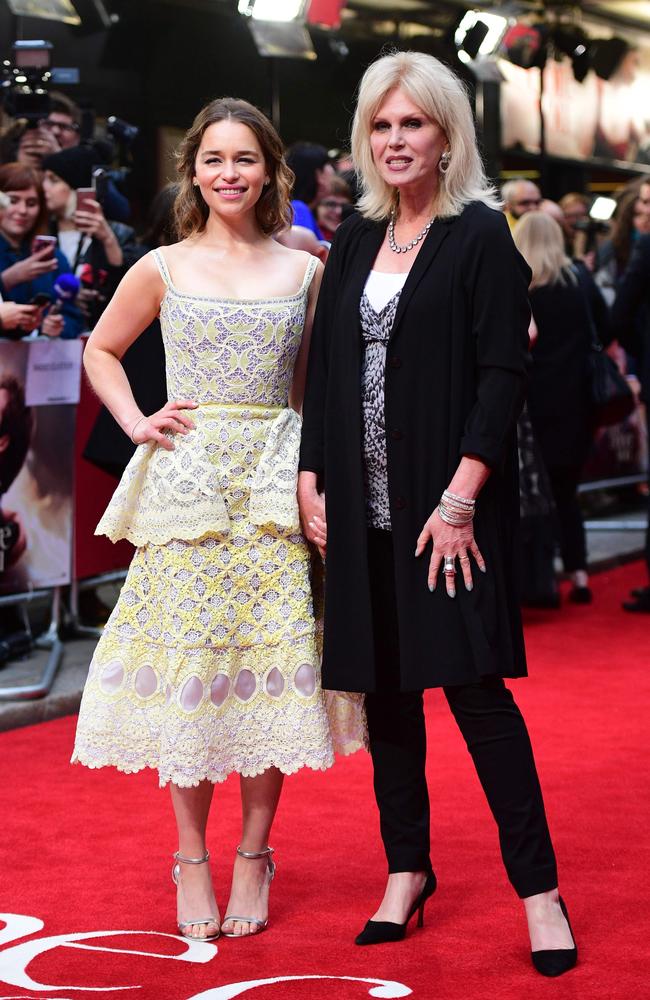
[72,632,367,787]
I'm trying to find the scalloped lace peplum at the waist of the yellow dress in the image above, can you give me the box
[95,404,301,547]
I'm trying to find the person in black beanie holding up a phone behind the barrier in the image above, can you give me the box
[43,146,141,326]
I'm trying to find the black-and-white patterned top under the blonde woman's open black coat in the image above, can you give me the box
[360,289,401,531]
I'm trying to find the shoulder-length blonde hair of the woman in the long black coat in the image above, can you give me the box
[352,52,501,221]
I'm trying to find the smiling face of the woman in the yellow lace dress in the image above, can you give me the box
[194,120,268,219]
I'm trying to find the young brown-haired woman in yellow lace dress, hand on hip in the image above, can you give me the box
[73,98,364,938]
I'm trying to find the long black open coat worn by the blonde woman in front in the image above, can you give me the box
[300,202,530,691]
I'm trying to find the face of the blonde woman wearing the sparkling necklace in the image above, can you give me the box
[370,87,449,197]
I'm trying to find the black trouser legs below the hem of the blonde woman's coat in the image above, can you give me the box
[366,677,557,898]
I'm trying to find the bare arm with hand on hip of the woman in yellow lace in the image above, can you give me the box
[84,255,196,450]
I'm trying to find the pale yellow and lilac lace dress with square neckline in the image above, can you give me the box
[72,250,366,787]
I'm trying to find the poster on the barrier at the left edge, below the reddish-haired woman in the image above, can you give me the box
[0,339,81,594]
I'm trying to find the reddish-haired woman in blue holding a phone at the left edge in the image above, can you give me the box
[0,163,84,338]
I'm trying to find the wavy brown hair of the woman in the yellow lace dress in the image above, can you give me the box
[174,97,294,239]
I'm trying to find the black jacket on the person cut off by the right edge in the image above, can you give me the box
[612,236,650,404]
